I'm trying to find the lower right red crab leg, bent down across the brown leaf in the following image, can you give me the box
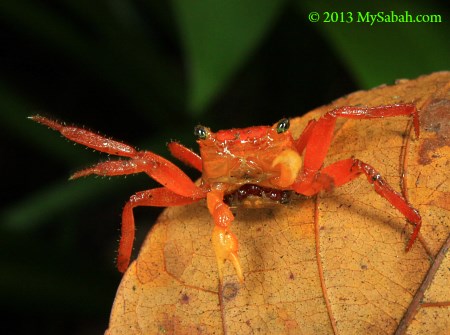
[298,158,422,251]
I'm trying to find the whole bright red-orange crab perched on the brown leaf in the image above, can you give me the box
[30,104,422,282]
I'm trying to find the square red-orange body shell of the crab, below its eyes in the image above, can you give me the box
[197,121,302,192]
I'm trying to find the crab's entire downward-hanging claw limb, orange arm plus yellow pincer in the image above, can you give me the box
[206,190,244,283]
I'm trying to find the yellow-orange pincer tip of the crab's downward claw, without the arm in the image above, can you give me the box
[212,226,244,283]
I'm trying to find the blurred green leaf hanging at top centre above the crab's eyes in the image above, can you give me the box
[173,0,284,115]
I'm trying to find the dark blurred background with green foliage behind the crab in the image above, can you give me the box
[0,0,450,334]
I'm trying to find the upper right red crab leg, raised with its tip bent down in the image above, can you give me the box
[296,104,420,175]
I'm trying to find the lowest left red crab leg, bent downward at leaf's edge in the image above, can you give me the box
[117,187,200,272]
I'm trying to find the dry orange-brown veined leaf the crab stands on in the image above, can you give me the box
[106,72,450,335]
